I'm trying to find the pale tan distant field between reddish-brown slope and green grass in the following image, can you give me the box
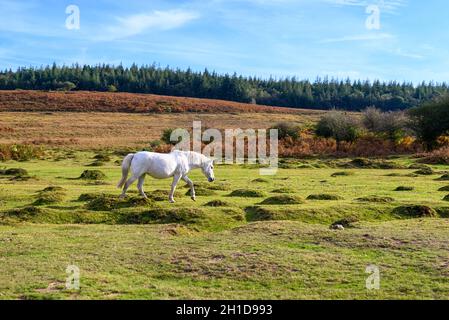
[0,111,321,150]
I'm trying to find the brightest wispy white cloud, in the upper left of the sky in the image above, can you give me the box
[97,10,199,40]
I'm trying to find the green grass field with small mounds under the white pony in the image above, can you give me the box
[0,150,449,299]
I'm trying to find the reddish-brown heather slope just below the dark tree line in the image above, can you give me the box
[0,90,321,115]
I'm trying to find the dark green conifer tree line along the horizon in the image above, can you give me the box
[0,64,449,111]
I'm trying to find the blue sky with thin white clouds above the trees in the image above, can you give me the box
[0,0,449,83]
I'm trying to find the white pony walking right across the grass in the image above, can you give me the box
[117,150,215,203]
